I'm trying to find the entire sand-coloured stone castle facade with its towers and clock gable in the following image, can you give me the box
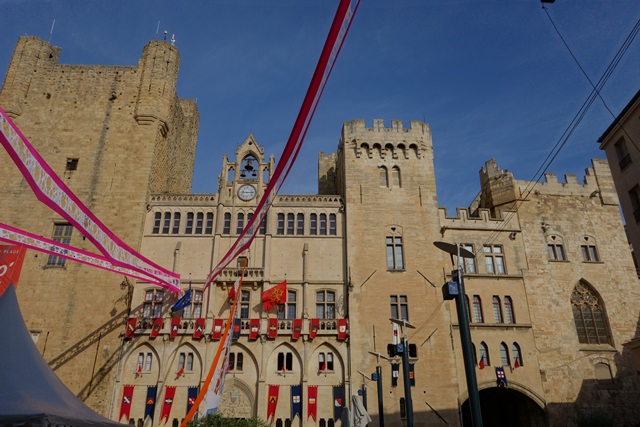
[0,38,640,427]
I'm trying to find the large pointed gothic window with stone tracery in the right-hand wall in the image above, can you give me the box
[571,282,611,344]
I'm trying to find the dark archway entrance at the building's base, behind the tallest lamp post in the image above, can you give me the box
[462,387,547,427]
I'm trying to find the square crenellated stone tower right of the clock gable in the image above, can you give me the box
[320,120,456,425]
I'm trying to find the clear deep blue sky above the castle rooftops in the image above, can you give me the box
[0,0,640,214]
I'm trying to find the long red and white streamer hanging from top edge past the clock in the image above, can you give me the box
[204,0,360,289]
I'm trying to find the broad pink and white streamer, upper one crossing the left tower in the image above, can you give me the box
[0,108,180,292]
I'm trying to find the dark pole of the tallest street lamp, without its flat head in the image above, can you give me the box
[451,269,482,427]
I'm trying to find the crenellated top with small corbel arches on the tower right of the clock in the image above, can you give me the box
[340,119,433,160]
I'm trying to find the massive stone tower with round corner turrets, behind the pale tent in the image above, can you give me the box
[0,37,199,414]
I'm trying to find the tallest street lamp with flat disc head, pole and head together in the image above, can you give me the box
[433,242,482,427]
